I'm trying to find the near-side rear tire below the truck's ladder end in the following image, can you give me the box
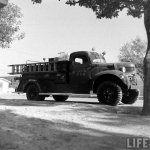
[26,84,45,101]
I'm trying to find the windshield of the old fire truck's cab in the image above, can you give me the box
[90,52,106,64]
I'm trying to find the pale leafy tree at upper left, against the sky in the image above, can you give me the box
[0,3,24,48]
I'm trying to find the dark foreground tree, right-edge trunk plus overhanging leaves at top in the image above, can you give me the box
[31,0,150,115]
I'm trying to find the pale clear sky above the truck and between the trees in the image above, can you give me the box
[0,0,147,76]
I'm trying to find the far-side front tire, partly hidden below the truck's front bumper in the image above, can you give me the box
[122,89,139,104]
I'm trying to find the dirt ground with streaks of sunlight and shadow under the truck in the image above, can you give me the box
[0,94,150,150]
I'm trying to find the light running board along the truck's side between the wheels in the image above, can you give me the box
[39,93,96,97]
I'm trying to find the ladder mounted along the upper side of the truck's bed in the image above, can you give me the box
[9,58,57,75]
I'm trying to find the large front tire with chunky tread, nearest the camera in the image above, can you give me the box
[97,81,122,106]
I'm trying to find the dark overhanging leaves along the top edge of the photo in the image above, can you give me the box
[32,0,144,19]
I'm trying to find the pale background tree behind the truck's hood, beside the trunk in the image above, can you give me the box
[118,38,146,80]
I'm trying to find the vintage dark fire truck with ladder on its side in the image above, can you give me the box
[10,51,139,105]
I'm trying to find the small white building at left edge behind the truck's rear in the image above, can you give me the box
[0,78,11,93]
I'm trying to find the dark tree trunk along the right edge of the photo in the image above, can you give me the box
[142,0,150,116]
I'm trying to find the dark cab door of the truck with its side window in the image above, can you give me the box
[69,53,91,94]
